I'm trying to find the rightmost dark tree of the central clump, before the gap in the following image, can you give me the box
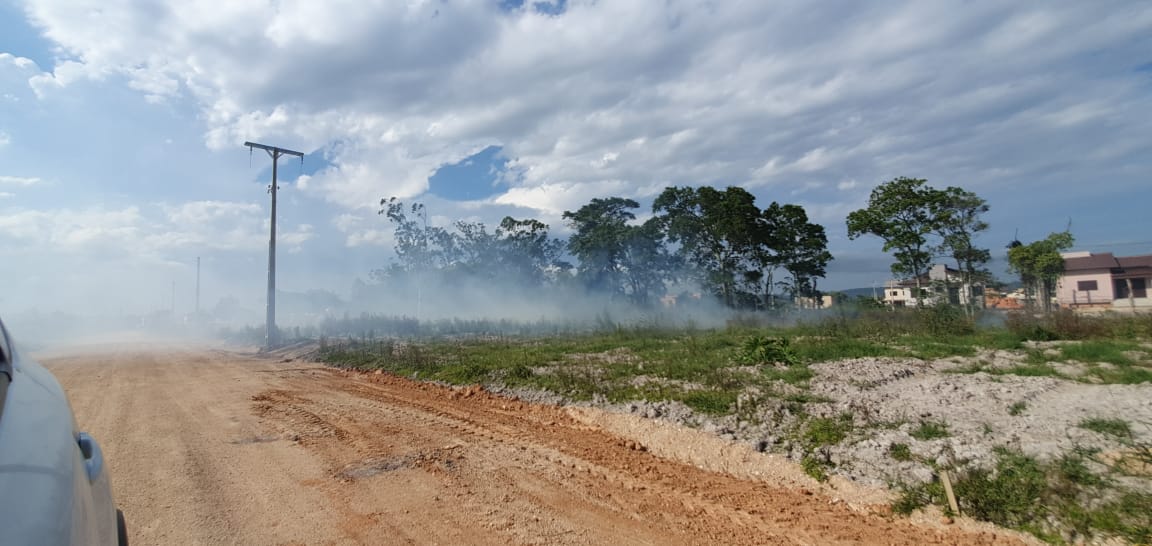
[763,202,832,301]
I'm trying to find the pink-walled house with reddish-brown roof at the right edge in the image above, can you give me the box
[1056,252,1152,311]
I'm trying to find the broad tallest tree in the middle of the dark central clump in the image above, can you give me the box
[652,185,766,306]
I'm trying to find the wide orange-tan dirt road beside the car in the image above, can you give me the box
[44,349,1016,545]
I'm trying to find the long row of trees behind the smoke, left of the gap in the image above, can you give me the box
[380,185,832,309]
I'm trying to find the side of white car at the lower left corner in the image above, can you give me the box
[0,323,128,545]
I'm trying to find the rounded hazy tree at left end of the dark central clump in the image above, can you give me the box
[563,197,669,304]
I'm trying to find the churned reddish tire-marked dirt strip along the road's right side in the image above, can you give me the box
[256,364,1032,544]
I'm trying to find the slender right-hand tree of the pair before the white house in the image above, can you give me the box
[935,187,992,312]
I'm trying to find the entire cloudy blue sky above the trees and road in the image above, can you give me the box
[0,0,1152,320]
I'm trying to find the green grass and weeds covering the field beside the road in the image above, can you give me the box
[321,309,1152,543]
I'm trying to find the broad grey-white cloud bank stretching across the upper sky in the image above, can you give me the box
[20,0,1152,222]
